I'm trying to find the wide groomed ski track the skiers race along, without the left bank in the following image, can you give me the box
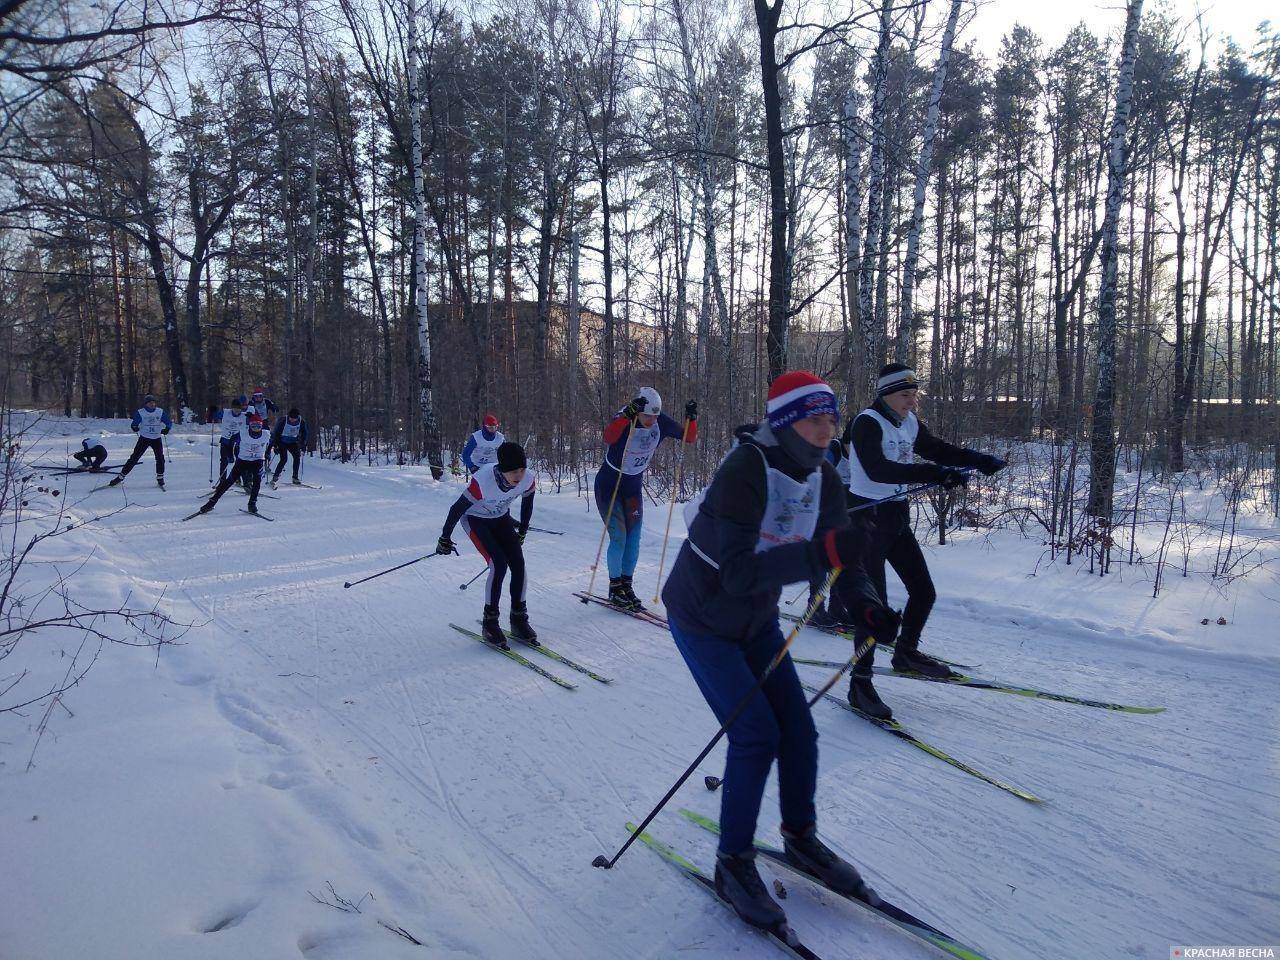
[17,438,1280,960]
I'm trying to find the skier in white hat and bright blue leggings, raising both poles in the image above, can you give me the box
[595,387,698,611]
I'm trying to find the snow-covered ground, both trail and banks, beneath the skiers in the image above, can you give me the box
[0,420,1280,960]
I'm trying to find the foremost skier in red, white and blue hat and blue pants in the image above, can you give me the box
[662,371,897,929]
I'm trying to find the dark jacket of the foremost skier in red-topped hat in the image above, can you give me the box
[662,424,876,643]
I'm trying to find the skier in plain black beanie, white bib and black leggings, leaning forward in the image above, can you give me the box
[435,440,538,650]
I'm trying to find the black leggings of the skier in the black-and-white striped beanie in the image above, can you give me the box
[836,503,938,676]
